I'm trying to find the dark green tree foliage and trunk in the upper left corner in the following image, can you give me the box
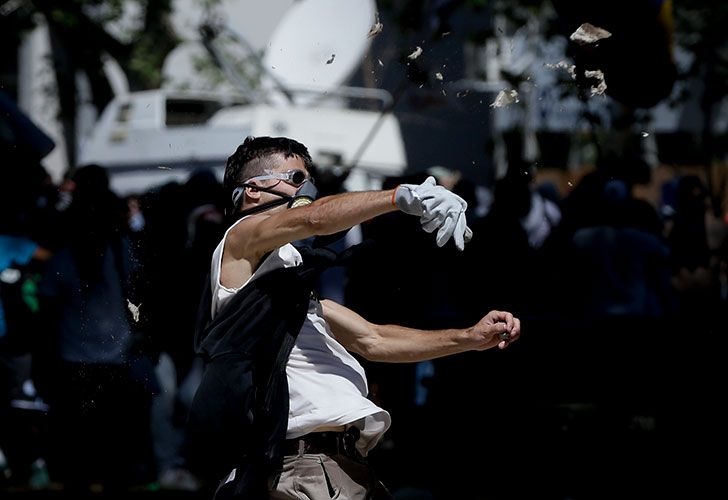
[0,0,179,165]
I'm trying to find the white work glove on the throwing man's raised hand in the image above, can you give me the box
[394,176,473,250]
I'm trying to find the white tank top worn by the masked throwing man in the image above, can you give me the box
[210,219,391,456]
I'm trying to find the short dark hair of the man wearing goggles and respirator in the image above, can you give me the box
[223,136,313,190]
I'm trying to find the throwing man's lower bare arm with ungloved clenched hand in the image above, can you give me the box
[321,300,521,363]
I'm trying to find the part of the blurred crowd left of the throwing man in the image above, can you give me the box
[0,155,223,491]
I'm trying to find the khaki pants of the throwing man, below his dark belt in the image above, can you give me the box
[270,454,392,500]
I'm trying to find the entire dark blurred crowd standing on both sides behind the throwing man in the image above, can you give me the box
[0,150,728,498]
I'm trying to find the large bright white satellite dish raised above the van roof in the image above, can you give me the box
[262,0,376,102]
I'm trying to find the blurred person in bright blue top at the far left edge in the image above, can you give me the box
[0,158,54,489]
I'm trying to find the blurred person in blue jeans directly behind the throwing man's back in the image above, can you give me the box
[137,169,225,491]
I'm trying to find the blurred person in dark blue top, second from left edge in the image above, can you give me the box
[40,165,158,492]
